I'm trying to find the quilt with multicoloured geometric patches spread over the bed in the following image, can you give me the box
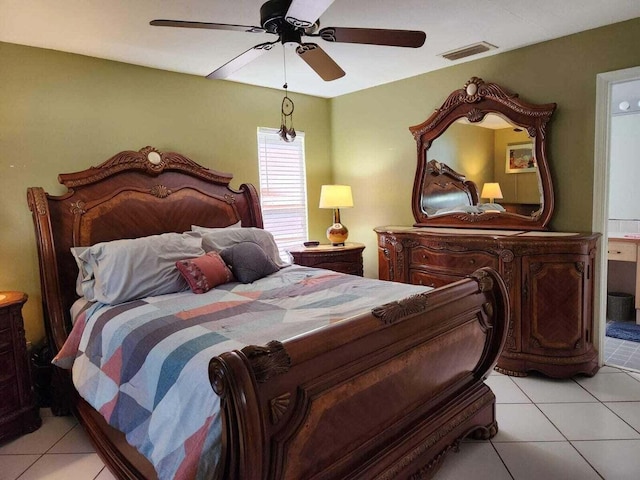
[54,265,428,479]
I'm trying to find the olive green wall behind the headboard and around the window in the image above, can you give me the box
[0,43,331,341]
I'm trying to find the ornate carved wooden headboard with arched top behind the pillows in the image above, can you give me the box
[27,147,263,350]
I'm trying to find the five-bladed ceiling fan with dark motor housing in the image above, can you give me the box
[149,0,426,81]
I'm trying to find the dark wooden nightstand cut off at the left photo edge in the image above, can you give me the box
[0,292,42,442]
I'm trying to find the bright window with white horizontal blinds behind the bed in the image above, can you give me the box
[258,127,307,261]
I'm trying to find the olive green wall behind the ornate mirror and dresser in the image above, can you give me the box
[331,19,640,276]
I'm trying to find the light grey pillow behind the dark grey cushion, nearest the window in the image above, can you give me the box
[191,225,290,267]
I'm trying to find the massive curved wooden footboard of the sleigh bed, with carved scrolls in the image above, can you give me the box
[209,269,509,480]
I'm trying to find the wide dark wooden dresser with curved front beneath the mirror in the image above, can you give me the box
[375,226,599,378]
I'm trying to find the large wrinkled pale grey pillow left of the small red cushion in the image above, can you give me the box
[71,233,205,305]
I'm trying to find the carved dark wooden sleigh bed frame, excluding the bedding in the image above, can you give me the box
[27,147,509,480]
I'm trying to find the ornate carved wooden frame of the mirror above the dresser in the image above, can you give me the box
[409,77,556,230]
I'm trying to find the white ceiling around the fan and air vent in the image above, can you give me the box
[0,0,640,98]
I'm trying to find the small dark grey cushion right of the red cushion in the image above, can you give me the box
[220,242,280,283]
